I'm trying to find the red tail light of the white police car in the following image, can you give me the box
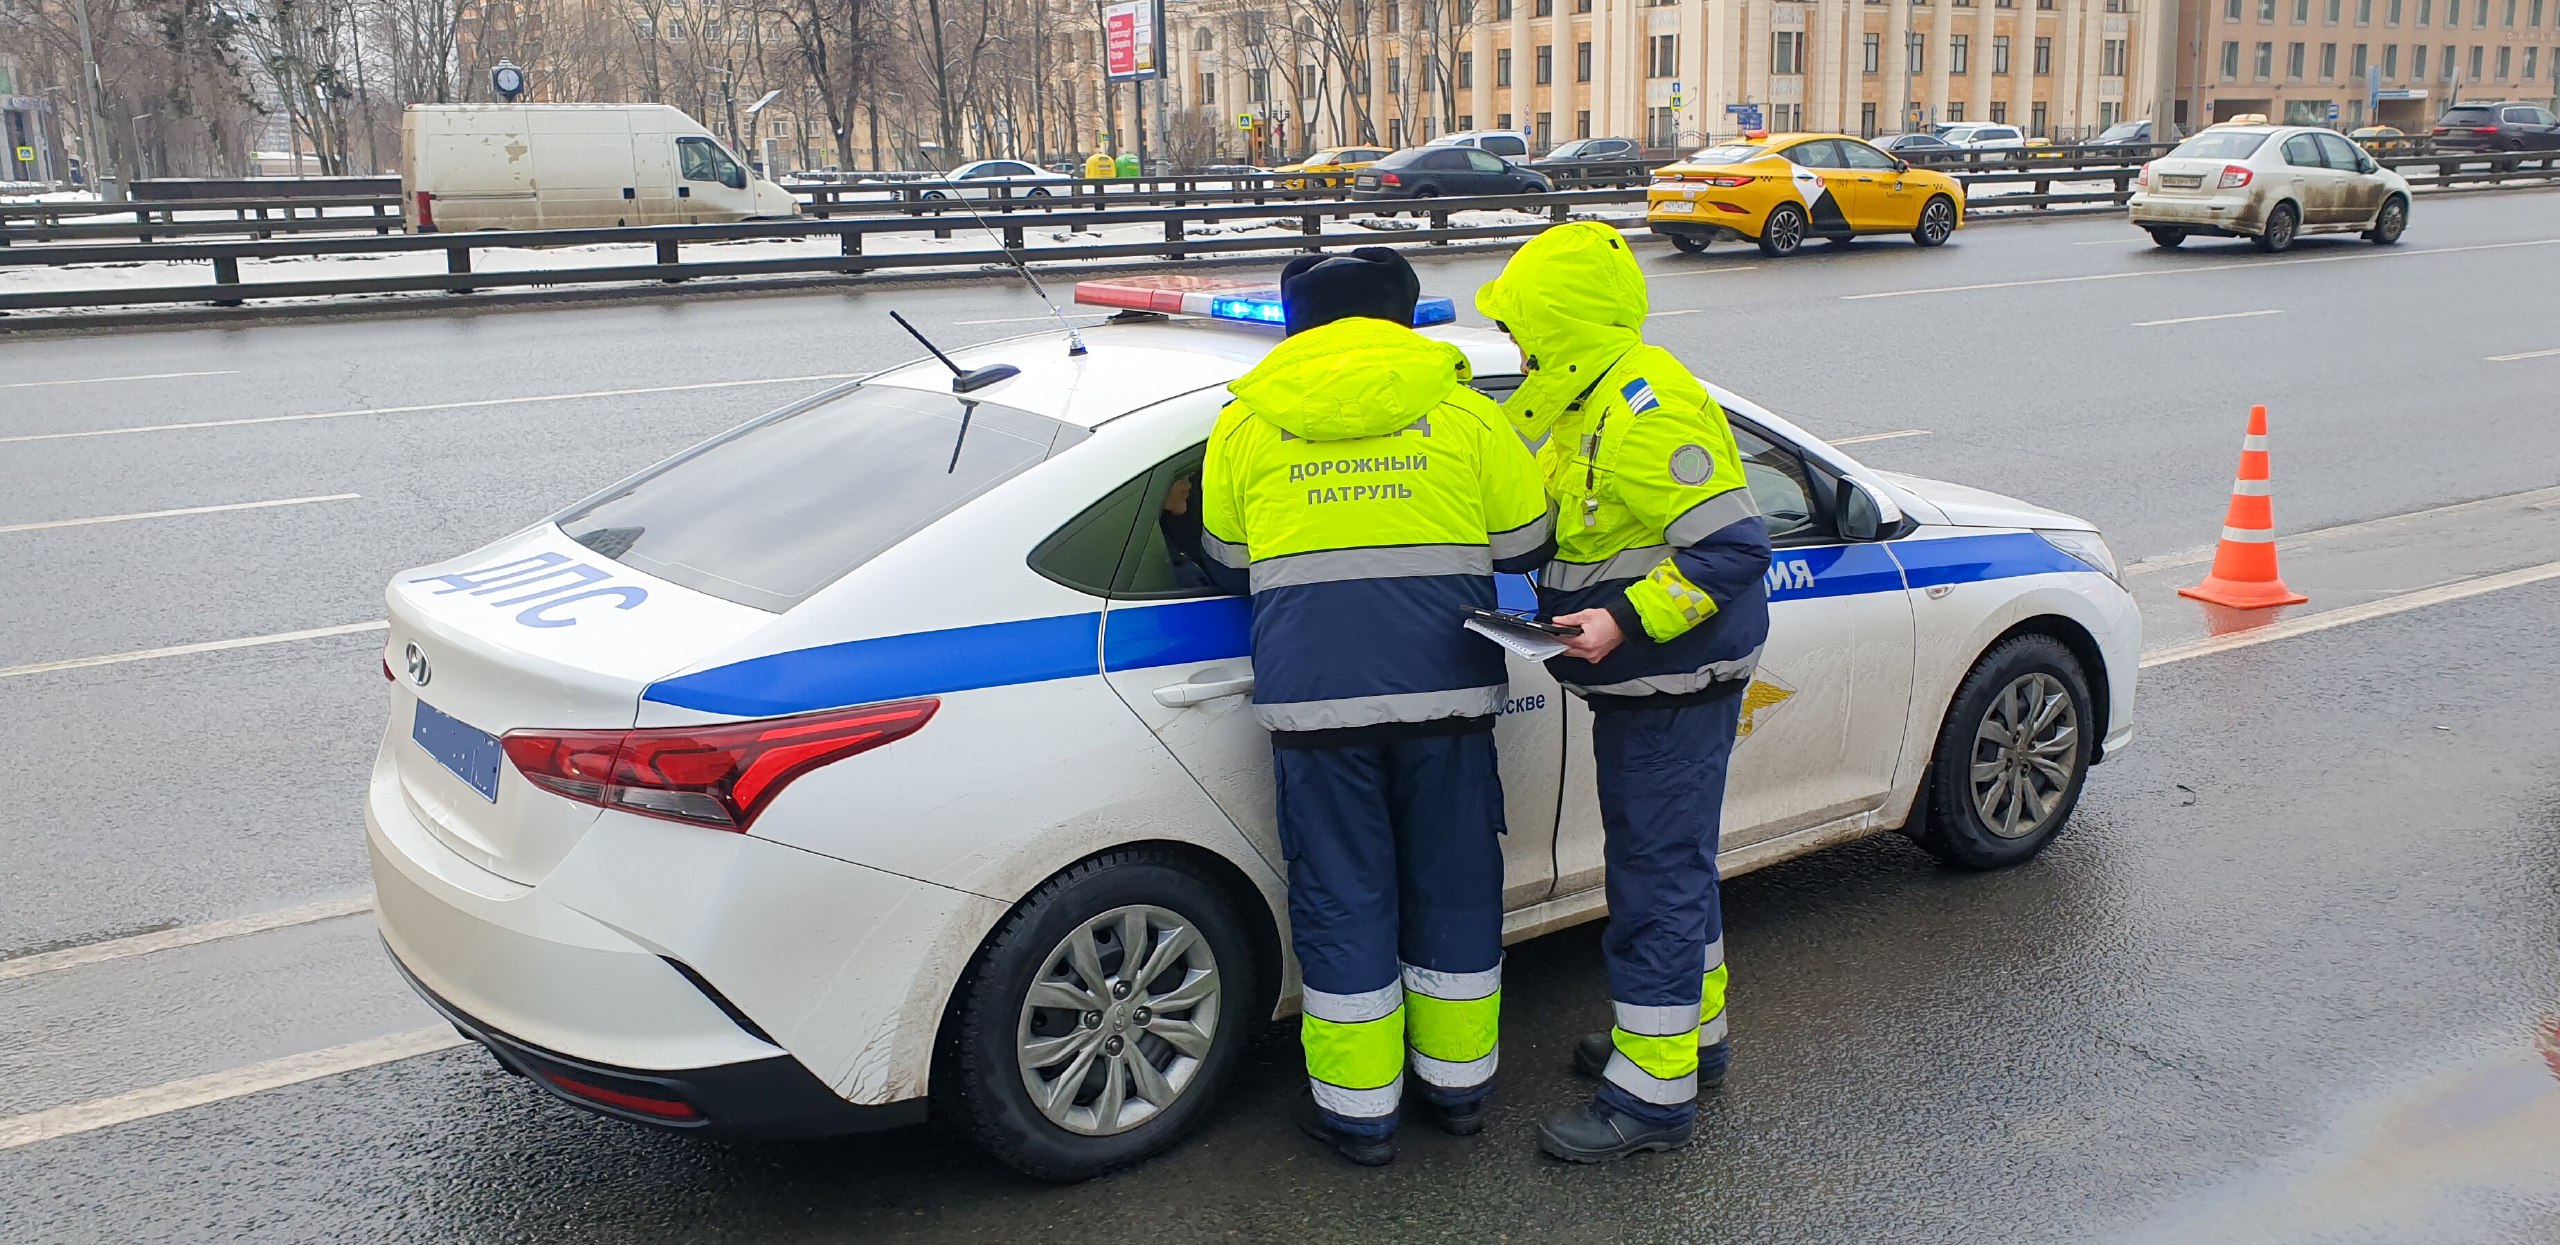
[499,697,942,833]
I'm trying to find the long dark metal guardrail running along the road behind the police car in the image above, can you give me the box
[0,151,2560,313]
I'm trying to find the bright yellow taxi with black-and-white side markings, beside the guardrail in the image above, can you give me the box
[1644,131,1964,259]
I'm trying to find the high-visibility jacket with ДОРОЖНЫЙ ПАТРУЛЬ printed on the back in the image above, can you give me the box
[1201,318,1554,743]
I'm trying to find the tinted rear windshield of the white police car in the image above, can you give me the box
[558,384,1085,612]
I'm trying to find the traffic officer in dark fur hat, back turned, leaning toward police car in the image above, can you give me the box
[1201,246,1554,1166]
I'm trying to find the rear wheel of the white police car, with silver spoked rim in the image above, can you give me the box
[932,848,1270,1181]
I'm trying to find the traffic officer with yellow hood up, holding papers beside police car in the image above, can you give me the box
[1477,220,1769,1163]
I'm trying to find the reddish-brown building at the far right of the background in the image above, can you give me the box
[2179,0,2560,131]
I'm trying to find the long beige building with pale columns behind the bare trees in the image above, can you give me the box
[1141,0,2160,151]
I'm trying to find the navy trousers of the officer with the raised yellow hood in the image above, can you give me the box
[1592,687,1743,1125]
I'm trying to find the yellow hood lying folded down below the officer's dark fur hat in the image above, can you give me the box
[1226,318,1469,441]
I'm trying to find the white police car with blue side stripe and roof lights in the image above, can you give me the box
[366,282,2138,1178]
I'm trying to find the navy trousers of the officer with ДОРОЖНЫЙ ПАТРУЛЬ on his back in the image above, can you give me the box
[1272,730,1505,1135]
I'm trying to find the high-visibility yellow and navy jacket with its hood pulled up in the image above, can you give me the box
[1477,220,1769,707]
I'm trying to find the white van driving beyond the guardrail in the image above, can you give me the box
[399,105,799,233]
